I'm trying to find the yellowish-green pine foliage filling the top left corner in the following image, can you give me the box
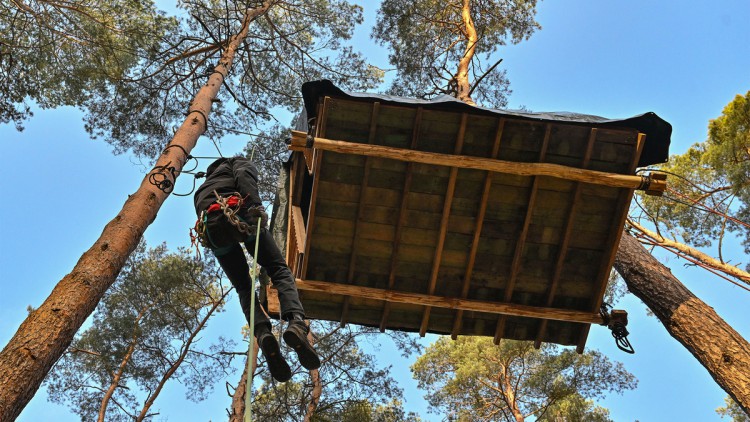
[0,0,176,130]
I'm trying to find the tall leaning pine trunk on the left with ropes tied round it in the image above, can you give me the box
[0,1,270,421]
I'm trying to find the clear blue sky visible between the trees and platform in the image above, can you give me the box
[0,0,750,422]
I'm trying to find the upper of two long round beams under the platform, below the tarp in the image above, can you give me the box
[289,131,666,192]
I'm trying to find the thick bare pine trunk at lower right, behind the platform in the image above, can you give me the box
[615,233,750,415]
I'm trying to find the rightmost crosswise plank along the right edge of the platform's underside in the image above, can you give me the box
[576,133,646,353]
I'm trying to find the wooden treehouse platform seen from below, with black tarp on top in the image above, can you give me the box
[269,81,671,352]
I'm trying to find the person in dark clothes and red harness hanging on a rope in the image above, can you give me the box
[194,156,320,382]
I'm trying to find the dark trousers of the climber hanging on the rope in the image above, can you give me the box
[213,228,305,333]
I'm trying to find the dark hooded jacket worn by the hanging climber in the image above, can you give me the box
[194,157,261,215]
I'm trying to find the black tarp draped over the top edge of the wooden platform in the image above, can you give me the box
[298,80,672,167]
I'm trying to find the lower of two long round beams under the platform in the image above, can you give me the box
[296,279,602,324]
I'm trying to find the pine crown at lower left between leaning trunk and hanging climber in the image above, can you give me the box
[47,244,231,421]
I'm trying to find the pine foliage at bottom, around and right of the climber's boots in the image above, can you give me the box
[253,321,420,422]
